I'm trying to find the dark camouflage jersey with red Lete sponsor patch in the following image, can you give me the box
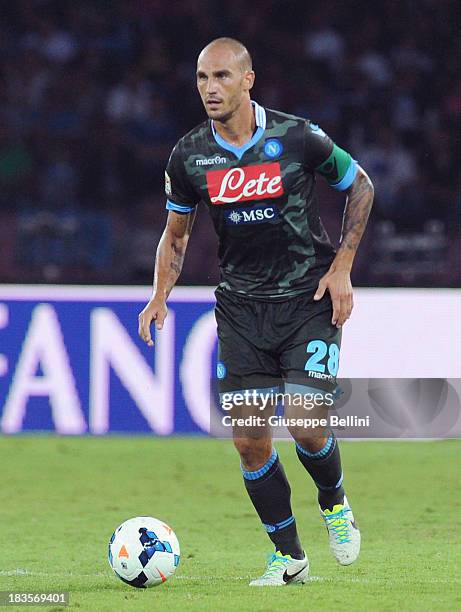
[165,102,357,300]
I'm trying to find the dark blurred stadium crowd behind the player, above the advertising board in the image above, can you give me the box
[0,0,461,286]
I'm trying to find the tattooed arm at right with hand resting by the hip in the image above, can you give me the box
[314,166,374,327]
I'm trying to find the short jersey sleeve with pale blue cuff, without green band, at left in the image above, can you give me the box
[165,143,199,214]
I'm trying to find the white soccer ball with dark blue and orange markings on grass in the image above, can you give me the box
[109,516,180,589]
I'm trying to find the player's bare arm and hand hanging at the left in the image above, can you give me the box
[138,210,195,346]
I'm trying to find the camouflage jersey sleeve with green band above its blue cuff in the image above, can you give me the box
[304,121,357,191]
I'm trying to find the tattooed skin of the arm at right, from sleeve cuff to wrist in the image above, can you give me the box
[339,172,374,251]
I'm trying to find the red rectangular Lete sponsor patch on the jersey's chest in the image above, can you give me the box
[206,162,283,204]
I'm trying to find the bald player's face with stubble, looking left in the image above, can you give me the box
[197,46,254,121]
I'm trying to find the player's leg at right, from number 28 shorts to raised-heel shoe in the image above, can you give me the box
[281,298,360,565]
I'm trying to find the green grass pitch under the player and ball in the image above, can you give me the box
[0,436,461,612]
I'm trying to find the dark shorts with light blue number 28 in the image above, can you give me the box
[215,289,341,394]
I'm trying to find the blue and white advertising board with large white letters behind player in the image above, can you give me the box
[0,285,461,436]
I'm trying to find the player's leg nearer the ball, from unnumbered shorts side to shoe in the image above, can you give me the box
[216,292,308,586]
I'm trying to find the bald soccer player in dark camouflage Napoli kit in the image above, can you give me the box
[139,38,373,586]
